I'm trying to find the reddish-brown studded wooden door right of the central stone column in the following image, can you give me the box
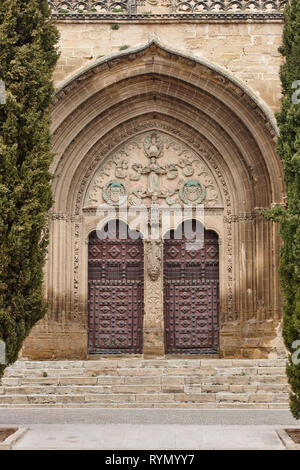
[164,221,219,354]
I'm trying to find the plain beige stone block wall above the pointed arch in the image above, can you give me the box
[54,19,283,111]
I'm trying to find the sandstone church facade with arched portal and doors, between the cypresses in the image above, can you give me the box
[22,0,285,359]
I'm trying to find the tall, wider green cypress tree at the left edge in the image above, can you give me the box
[0,0,58,377]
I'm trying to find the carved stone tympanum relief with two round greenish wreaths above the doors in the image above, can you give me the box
[85,131,223,208]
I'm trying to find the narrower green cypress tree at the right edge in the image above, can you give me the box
[265,0,300,419]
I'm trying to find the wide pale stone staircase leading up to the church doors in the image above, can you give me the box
[0,358,289,409]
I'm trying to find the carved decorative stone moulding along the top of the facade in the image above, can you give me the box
[49,0,288,16]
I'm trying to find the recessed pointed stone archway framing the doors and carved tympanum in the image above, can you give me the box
[24,40,284,358]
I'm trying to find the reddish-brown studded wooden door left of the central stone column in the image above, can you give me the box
[88,223,144,354]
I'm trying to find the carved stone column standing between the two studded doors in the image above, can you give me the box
[143,241,165,357]
